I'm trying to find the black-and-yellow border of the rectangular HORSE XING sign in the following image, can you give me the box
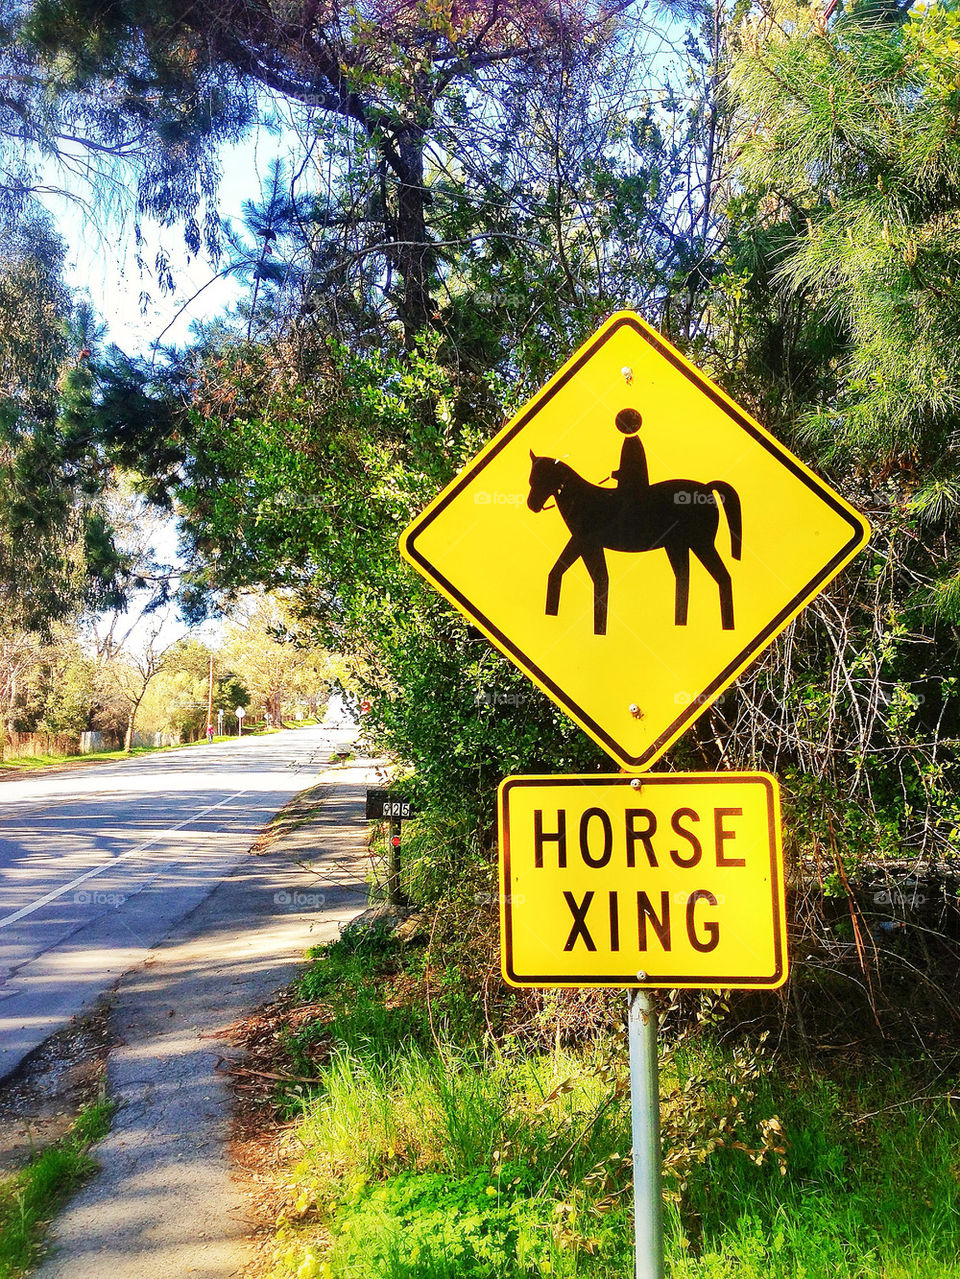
[497,773,790,990]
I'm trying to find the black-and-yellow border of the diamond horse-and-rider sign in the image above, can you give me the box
[400,311,871,773]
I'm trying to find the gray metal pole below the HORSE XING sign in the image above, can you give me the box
[628,990,665,1279]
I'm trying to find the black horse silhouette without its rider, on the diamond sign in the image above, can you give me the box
[527,449,743,636]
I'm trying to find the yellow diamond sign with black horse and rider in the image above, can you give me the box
[400,312,869,770]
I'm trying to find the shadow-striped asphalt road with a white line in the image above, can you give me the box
[0,725,355,1078]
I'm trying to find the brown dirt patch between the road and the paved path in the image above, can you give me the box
[0,1001,112,1172]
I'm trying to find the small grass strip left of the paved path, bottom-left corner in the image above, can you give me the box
[0,1101,112,1279]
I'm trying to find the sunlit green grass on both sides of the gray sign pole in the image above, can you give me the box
[259,938,960,1279]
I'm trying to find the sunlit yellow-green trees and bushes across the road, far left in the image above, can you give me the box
[0,592,354,767]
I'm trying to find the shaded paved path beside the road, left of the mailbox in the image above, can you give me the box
[28,760,377,1279]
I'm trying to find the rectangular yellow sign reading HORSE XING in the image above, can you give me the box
[500,773,787,990]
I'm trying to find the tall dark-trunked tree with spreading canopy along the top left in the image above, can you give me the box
[23,0,654,349]
